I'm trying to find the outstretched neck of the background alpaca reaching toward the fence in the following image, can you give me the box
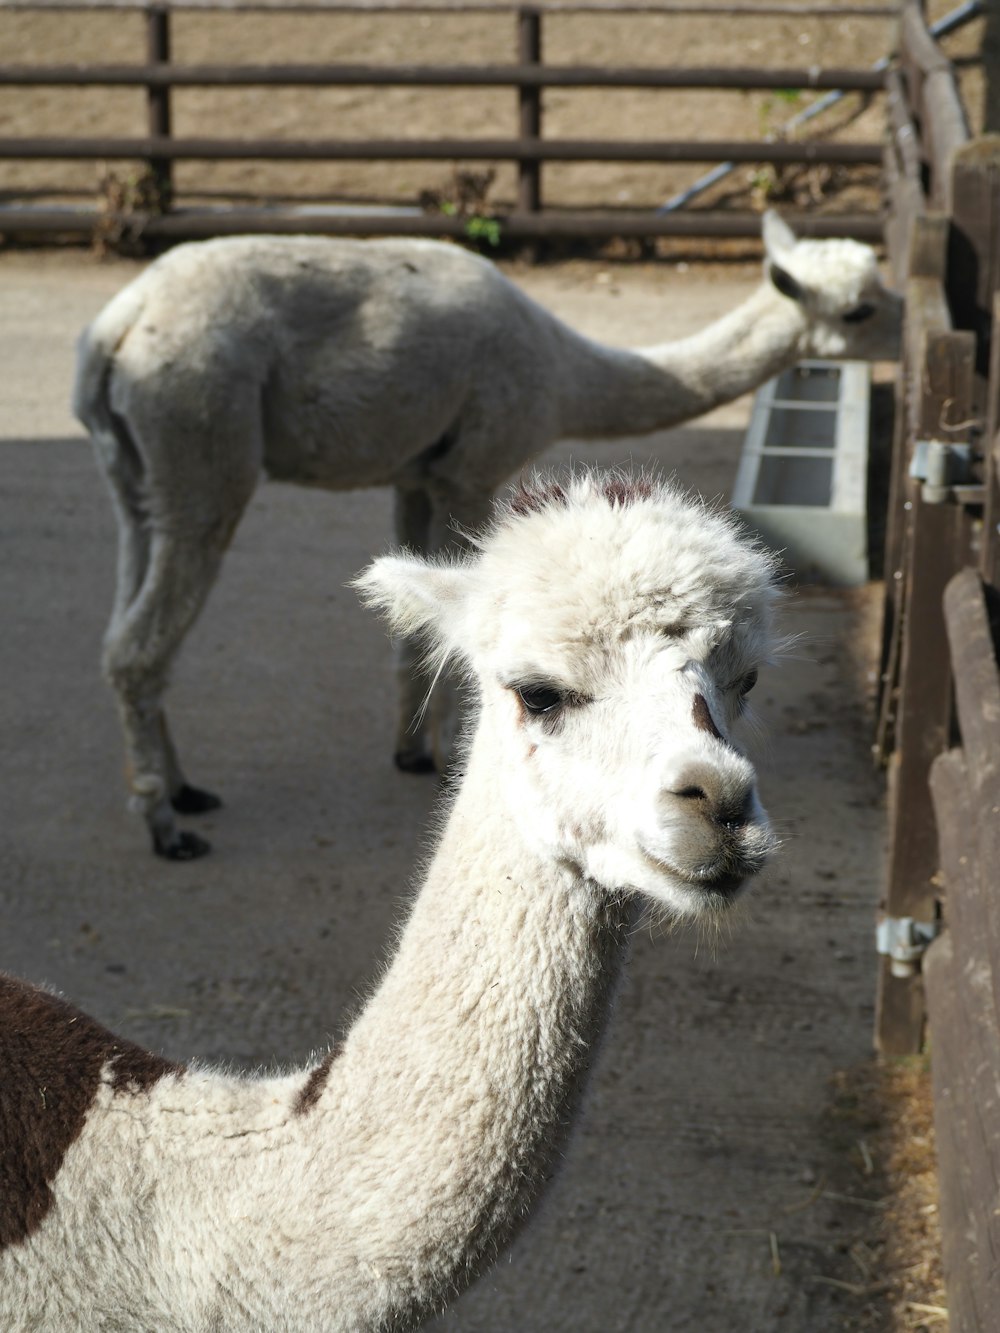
[561,283,807,439]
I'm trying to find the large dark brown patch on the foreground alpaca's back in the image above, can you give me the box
[0,974,184,1249]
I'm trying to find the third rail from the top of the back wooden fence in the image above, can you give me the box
[0,137,883,164]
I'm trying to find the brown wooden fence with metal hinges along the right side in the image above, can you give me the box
[876,0,1000,1333]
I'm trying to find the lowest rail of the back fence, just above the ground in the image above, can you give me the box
[0,207,883,241]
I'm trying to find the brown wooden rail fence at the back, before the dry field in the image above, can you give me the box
[0,0,897,239]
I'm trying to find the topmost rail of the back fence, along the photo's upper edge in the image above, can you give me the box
[0,0,899,19]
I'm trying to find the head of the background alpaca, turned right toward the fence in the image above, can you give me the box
[764,212,903,361]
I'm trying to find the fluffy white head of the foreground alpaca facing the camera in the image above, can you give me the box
[359,473,775,916]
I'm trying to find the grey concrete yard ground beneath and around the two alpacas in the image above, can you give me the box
[0,252,883,1333]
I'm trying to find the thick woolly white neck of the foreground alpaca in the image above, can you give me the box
[309,735,631,1328]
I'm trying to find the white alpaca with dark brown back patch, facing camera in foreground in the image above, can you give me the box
[0,475,773,1333]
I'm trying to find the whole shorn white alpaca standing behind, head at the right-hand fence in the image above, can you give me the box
[75,207,900,860]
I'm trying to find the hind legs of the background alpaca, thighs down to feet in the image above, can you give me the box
[95,378,264,860]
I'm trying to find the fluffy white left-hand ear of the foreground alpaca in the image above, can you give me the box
[353,556,469,640]
